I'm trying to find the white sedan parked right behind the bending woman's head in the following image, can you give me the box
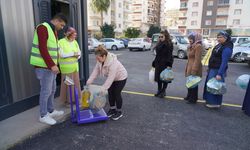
[99,38,124,50]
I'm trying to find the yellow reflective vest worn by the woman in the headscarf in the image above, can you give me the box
[58,38,80,74]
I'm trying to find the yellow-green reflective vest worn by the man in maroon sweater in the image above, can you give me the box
[30,22,58,67]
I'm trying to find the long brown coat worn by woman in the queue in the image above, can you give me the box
[185,43,202,77]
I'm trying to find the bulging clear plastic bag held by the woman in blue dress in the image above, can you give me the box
[207,78,227,95]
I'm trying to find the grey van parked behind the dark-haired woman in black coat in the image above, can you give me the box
[151,33,189,59]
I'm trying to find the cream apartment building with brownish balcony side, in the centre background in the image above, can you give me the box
[131,0,162,34]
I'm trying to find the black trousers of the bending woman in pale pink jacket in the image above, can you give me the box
[108,79,127,109]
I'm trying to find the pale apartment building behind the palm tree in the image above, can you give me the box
[87,0,131,36]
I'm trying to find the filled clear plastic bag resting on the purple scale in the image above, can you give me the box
[89,93,107,112]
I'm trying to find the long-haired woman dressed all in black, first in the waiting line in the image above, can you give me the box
[152,30,173,98]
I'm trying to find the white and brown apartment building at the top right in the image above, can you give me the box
[178,0,250,37]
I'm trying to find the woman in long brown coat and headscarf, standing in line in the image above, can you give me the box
[184,32,202,104]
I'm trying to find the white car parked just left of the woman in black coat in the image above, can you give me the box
[128,38,151,51]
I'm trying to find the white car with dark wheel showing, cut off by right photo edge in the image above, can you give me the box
[231,41,250,62]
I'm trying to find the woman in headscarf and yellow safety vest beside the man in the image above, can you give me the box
[58,27,81,105]
